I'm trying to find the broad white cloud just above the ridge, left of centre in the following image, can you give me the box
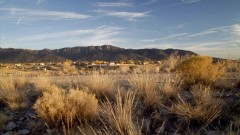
[12,25,128,49]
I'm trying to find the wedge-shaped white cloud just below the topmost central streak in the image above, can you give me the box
[94,10,150,21]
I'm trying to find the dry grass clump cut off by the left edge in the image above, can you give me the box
[0,77,27,110]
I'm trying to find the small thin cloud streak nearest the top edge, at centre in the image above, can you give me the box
[95,2,132,7]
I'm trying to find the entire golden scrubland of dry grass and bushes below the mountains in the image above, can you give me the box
[0,56,240,135]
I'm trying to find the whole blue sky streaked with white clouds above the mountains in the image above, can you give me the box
[0,0,240,59]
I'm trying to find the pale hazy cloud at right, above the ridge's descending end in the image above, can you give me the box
[141,24,240,59]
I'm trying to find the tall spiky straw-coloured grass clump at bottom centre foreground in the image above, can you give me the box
[100,91,140,135]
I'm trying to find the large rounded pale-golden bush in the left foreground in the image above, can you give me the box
[34,85,98,127]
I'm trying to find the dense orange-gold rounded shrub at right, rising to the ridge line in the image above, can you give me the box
[178,56,225,85]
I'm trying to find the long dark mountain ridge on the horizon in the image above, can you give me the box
[0,45,197,63]
